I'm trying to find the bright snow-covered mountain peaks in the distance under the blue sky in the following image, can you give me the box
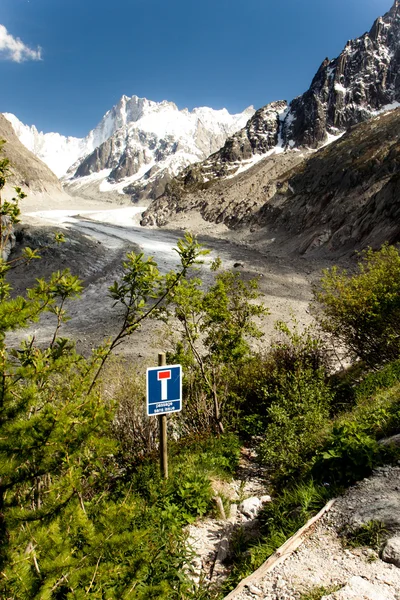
[5,95,255,200]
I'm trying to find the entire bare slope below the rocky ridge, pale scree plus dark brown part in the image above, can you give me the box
[142,109,400,254]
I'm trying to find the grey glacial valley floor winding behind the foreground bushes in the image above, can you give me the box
[11,196,340,362]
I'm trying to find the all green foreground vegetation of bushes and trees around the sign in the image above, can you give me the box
[0,144,400,600]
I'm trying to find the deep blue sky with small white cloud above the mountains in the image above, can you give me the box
[0,0,393,136]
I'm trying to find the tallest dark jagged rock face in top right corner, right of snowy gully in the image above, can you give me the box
[282,0,400,148]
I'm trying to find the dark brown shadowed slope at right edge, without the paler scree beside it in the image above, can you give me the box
[258,109,400,253]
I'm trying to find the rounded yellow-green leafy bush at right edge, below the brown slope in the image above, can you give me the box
[314,244,400,368]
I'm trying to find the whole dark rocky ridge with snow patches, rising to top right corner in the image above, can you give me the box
[162,0,400,187]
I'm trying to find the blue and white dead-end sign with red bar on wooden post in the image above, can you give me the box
[147,365,182,417]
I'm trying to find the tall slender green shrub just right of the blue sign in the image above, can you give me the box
[169,260,269,433]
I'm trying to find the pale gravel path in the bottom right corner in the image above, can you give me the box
[230,467,400,600]
